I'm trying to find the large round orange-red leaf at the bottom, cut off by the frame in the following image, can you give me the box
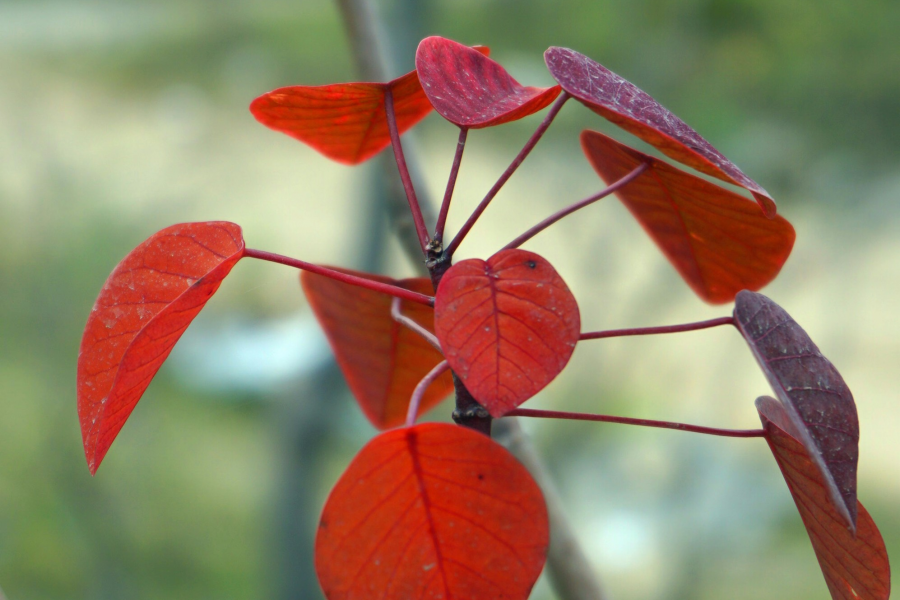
[316,423,549,600]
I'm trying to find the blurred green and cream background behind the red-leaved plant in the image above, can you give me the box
[0,0,900,600]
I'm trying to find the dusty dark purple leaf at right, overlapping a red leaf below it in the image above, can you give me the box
[734,291,859,529]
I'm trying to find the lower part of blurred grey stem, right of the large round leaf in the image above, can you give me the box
[494,419,606,600]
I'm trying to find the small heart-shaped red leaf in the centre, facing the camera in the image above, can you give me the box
[434,249,581,417]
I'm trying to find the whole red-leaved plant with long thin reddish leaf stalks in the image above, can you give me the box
[78,37,890,600]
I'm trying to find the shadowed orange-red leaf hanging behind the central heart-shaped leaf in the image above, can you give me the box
[300,269,453,429]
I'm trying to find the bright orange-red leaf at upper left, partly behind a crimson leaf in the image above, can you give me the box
[250,46,490,165]
